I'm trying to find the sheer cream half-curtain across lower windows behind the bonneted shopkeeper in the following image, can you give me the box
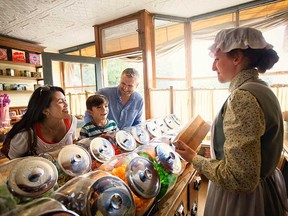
[150,85,288,124]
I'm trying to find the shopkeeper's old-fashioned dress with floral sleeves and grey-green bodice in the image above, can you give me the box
[193,69,287,216]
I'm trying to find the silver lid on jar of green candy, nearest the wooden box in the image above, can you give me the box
[156,143,182,174]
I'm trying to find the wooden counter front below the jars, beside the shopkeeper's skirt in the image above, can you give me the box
[146,164,198,216]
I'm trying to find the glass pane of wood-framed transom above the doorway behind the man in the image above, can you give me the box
[102,20,139,54]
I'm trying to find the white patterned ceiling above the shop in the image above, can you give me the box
[0,0,251,51]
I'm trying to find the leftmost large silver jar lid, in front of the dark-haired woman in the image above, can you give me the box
[7,157,58,197]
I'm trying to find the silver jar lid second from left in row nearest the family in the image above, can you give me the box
[57,144,92,177]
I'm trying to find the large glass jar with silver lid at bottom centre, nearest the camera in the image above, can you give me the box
[52,170,135,216]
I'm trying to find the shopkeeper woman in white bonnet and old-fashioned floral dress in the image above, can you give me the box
[176,27,287,216]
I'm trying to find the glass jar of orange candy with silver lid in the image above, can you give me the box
[99,152,160,215]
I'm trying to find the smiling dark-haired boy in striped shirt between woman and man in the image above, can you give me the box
[79,94,118,139]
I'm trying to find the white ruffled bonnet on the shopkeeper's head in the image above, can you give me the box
[209,27,273,53]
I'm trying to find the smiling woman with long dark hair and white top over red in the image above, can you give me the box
[1,85,77,159]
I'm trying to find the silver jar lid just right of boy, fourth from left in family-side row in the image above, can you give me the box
[116,130,136,151]
